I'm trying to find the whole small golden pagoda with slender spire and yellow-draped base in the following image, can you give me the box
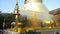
[11,0,22,33]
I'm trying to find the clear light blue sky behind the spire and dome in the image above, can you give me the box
[0,0,60,13]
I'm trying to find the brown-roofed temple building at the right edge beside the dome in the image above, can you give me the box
[49,8,60,27]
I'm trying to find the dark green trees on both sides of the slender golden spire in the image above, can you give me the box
[0,14,27,29]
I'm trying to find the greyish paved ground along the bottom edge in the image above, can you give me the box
[0,29,60,34]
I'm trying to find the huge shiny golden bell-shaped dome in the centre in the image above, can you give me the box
[22,0,52,27]
